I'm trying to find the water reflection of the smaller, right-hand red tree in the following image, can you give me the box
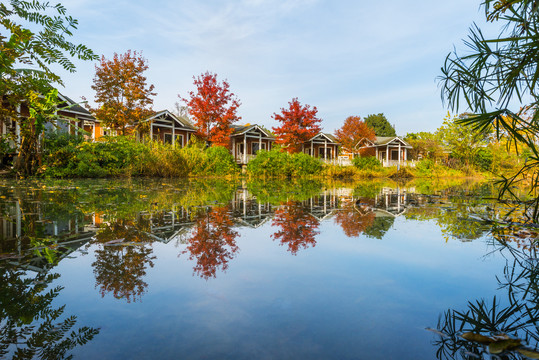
[272,201,320,255]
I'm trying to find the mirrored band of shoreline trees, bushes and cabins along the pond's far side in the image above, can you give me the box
[0,180,510,296]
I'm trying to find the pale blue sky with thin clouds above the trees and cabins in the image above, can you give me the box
[57,0,484,135]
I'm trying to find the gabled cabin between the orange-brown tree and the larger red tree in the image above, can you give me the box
[137,110,196,147]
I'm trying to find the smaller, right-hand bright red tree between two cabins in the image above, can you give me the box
[272,98,322,153]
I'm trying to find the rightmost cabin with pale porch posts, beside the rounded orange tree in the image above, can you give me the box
[356,136,415,167]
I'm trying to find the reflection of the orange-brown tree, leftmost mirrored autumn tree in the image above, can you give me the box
[92,219,155,302]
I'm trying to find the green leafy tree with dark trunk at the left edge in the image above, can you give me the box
[0,0,97,175]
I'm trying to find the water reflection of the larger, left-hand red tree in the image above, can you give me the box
[182,206,239,279]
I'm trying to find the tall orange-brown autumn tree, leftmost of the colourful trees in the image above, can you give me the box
[90,50,156,135]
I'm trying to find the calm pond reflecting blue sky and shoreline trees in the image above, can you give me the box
[0,180,539,359]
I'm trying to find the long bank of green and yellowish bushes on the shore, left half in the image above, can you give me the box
[42,136,238,177]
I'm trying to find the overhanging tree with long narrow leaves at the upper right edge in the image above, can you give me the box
[441,0,539,221]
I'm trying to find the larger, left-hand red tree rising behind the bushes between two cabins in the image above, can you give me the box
[180,72,241,147]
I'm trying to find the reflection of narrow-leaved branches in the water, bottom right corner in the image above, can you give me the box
[429,204,539,359]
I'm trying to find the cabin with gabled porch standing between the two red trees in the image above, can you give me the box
[230,124,275,165]
